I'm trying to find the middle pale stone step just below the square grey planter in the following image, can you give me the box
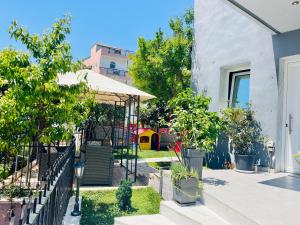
[160,201,230,225]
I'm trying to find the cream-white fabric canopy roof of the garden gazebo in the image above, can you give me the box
[58,69,155,104]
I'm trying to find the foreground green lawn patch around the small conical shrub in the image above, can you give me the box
[80,188,161,225]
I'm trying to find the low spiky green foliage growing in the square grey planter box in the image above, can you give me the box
[171,163,198,184]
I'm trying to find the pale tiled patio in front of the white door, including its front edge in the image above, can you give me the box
[203,170,300,225]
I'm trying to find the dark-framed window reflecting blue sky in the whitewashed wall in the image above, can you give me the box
[228,70,250,109]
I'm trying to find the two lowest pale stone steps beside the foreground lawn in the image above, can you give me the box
[115,201,230,225]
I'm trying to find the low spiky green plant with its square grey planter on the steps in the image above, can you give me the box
[171,163,199,205]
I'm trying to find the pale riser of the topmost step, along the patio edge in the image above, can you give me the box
[202,190,258,225]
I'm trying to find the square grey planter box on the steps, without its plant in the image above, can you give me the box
[173,178,199,205]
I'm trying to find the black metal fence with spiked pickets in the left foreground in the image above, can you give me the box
[1,139,76,225]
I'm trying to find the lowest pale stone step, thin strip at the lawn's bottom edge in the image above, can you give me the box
[115,214,178,225]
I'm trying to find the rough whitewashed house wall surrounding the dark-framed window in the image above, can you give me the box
[192,0,278,164]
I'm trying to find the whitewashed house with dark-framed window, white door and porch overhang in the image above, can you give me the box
[192,0,300,172]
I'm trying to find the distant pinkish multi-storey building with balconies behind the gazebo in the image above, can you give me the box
[83,43,134,84]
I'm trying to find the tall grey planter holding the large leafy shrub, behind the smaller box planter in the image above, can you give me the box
[182,148,205,180]
